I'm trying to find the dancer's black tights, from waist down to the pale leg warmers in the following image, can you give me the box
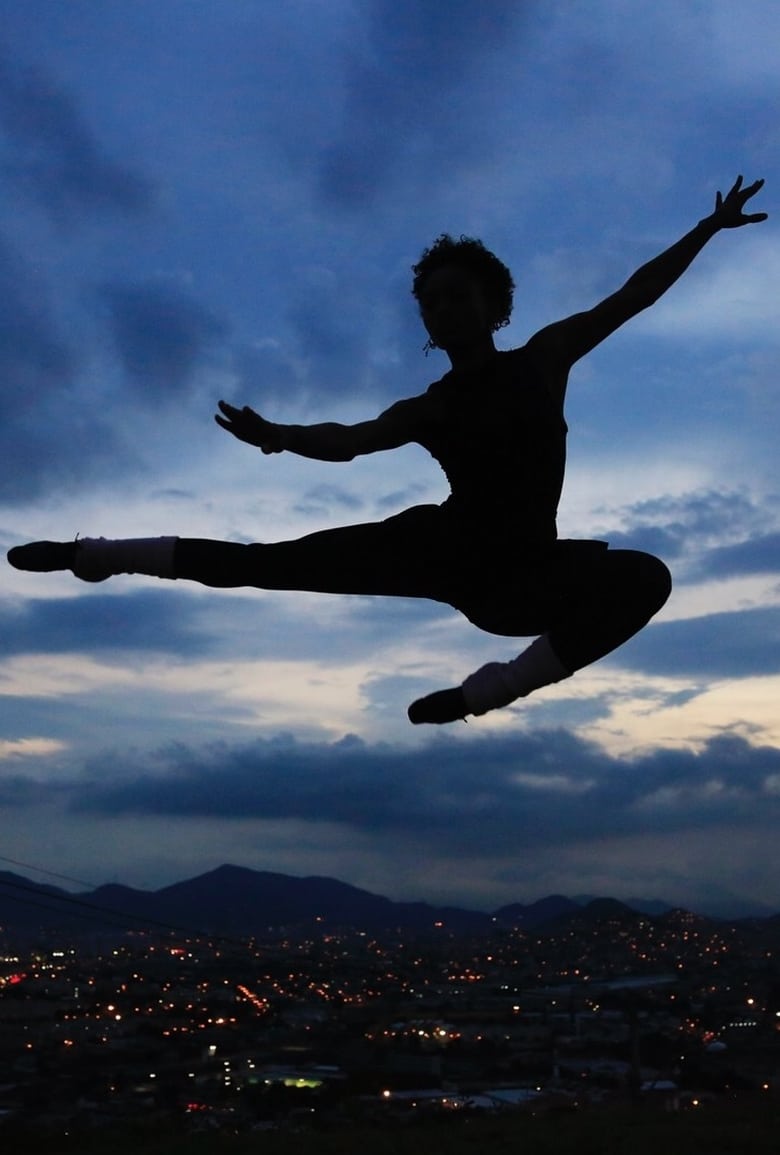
[174,506,671,673]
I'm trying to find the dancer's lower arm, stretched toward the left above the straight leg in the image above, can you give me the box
[214,401,415,461]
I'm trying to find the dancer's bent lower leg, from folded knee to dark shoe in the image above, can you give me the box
[409,550,671,723]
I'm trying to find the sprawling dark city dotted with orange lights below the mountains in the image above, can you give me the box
[0,915,780,1125]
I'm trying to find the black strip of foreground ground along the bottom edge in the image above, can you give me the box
[9,1101,780,1155]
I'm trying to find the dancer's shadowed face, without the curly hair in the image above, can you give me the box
[418,263,491,350]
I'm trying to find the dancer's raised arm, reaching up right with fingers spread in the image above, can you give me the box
[529,177,767,381]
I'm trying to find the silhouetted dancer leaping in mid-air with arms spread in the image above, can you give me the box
[8,177,766,723]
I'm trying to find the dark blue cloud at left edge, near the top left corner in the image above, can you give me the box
[0,50,153,225]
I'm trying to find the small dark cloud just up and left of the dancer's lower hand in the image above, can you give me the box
[101,282,225,400]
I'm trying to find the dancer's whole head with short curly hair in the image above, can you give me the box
[411,233,514,349]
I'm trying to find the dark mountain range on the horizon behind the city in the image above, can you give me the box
[0,865,780,938]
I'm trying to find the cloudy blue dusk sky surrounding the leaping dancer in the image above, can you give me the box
[0,0,780,911]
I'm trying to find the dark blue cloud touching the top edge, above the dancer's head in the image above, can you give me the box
[320,0,519,210]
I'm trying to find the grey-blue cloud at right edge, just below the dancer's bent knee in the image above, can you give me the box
[612,609,780,678]
